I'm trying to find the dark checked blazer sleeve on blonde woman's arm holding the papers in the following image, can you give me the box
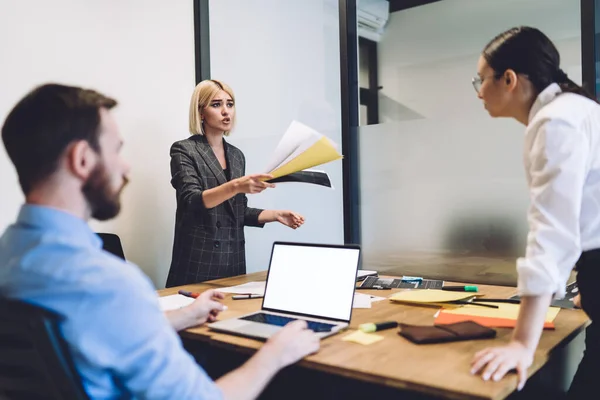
[170,142,206,211]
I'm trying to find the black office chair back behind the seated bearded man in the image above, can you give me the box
[0,298,89,400]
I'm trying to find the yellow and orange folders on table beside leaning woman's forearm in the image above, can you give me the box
[435,302,560,329]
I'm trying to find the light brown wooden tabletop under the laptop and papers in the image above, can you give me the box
[159,272,588,399]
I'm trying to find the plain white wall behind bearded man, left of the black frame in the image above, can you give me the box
[0,0,194,287]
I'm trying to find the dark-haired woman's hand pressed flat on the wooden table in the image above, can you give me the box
[471,340,533,390]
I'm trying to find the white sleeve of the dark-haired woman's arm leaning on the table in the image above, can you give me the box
[517,120,589,298]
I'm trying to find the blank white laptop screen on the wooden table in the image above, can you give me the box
[263,243,360,321]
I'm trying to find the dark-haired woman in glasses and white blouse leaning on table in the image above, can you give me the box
[471,27,600,399]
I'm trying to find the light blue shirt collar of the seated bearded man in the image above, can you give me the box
[17,204,102,248]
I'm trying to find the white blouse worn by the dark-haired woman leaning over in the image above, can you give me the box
[517,83,600,298]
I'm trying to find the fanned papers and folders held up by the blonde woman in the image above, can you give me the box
[265,121,342,187]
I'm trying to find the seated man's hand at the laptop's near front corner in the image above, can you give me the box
[263,321,320,369]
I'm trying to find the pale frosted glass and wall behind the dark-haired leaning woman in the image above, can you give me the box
[360,0,581,274]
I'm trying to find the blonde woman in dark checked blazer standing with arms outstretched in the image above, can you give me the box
[166,79,304,287]
